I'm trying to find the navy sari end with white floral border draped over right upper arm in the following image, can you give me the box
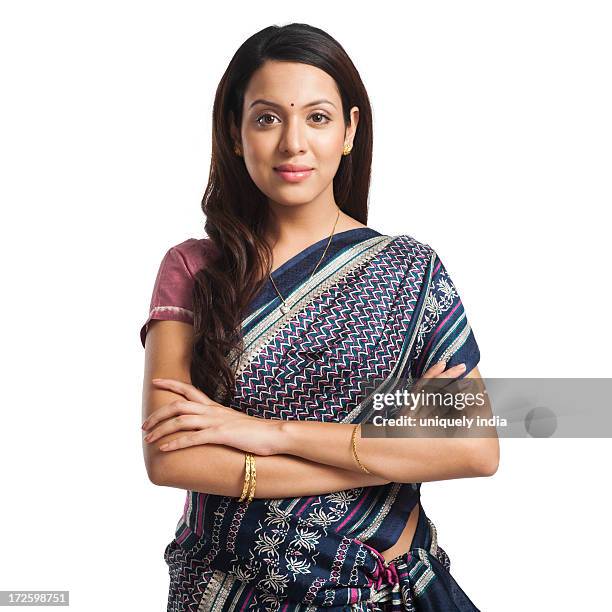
[410,249,480,379]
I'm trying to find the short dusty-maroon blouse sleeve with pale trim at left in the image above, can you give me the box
[140,238,206,347]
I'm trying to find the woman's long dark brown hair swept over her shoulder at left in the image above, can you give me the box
[191,23,372,405]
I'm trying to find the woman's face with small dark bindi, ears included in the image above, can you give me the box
[233,61,359,205]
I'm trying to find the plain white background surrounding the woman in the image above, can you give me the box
[0,0,612,612]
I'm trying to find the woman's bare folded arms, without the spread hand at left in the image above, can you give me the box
[143,321,499,498]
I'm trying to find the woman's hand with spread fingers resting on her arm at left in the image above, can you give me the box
[142,378,280,455]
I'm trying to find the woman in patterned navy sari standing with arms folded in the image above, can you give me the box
[141,24,498,611]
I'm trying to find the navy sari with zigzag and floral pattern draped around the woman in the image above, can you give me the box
[157,227,480,612]
